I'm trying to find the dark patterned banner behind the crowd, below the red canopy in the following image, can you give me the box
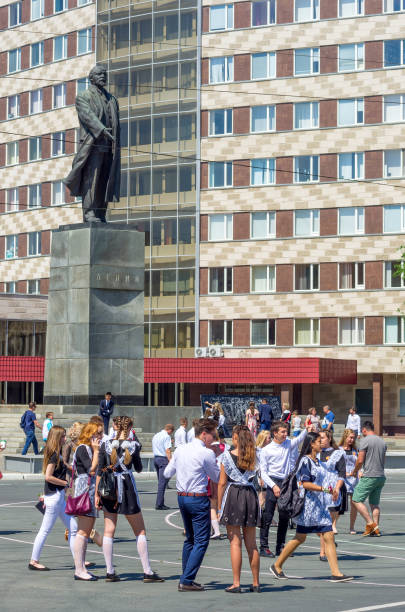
[200,393,281,431]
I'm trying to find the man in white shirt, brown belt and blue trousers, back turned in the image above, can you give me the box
[164,419,219,591]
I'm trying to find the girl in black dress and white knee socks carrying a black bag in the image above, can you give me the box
[96,416,164,582]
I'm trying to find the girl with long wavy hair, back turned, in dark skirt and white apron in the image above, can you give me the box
[218,425,260,593]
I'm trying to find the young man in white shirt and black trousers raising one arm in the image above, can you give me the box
[260,421,307,557]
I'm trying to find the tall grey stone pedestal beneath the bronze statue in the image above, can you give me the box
[44,223,145,405]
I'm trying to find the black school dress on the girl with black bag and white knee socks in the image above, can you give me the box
[97,440,142,514]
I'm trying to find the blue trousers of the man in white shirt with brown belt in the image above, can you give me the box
[178,496,211,584]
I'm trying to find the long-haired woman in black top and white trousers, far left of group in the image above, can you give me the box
[28,425,77,572]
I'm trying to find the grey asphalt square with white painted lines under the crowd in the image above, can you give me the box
[0,472,405,612]
